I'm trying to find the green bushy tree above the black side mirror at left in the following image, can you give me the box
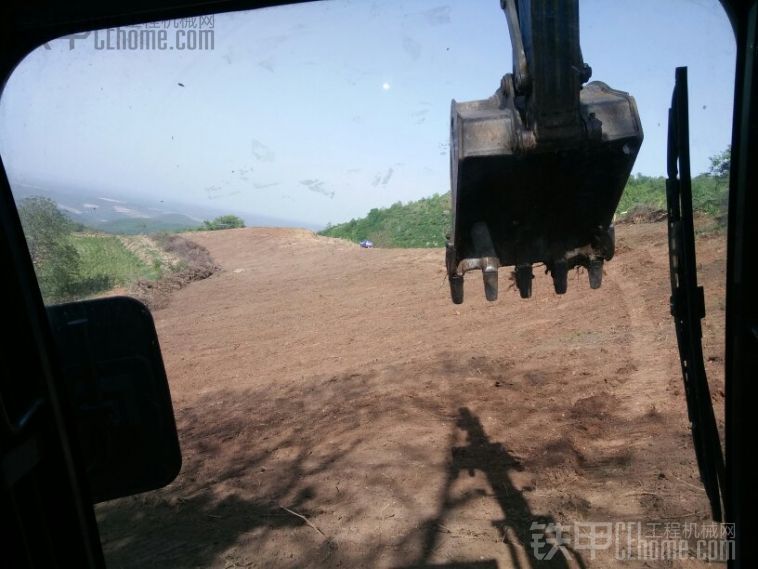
[18,196,80,302]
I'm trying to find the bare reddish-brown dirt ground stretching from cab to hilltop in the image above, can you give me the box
[98,223,725,569]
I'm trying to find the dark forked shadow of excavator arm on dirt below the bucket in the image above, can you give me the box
[396,407,586,569]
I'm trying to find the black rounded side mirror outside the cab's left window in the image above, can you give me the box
[47,297,182,503]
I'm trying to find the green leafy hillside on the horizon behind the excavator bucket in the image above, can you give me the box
[321,174,728,247]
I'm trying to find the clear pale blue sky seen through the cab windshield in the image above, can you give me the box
[0,0,735,224]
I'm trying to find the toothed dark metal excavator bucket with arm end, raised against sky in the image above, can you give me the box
[446,0,643,304]
